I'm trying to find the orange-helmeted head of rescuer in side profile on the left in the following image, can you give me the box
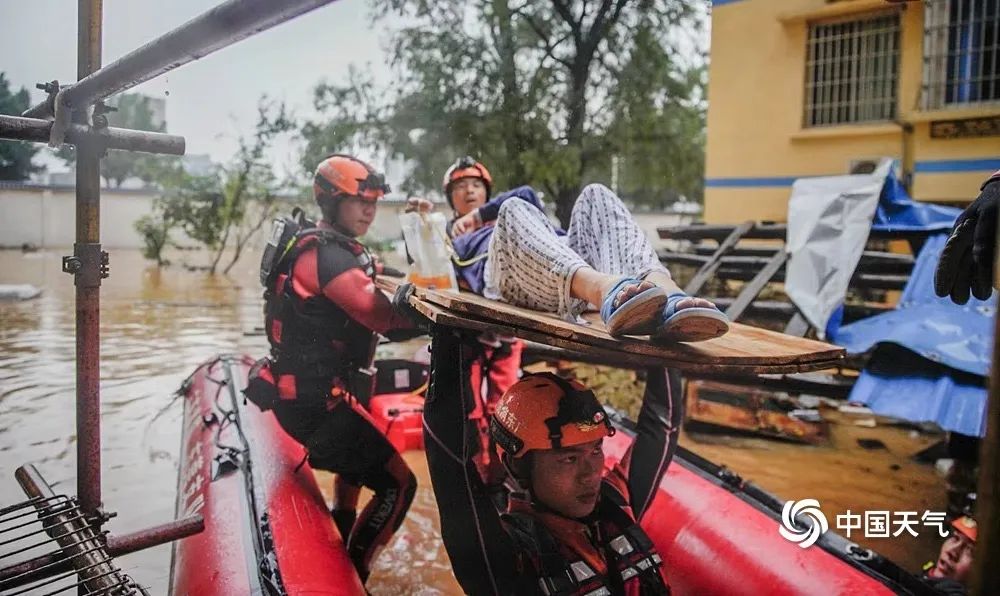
[313,154,389,238]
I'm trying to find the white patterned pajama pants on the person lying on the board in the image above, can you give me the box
[483,184,667,321]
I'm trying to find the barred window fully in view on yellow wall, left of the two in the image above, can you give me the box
[803,12,899,126]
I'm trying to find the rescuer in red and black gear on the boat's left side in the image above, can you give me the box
[246,155,422,581]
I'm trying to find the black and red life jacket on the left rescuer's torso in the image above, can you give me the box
[261,218,375,383]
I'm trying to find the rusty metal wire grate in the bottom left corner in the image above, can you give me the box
[0,495,144,596]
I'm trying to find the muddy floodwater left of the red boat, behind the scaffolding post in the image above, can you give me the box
[0,249,266,594]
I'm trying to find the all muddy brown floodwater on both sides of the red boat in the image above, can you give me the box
[0,250,945,594]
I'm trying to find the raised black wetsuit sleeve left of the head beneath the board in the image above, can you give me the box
[424,327,518,596]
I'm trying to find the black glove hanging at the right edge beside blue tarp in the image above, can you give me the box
[934,179,1000,304]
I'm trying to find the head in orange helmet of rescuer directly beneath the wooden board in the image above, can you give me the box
[490,373,615,518]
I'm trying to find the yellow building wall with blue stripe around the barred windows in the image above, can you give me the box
[705,0,1000,223]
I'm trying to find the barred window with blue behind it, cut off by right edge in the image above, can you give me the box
[923,0,1000,109]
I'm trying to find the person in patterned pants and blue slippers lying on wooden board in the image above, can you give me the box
[407,157,729,342]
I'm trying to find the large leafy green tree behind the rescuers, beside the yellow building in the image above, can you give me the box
[303,0,704,225]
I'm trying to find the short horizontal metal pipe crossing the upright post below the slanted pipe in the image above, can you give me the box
[0,115,184,155]
